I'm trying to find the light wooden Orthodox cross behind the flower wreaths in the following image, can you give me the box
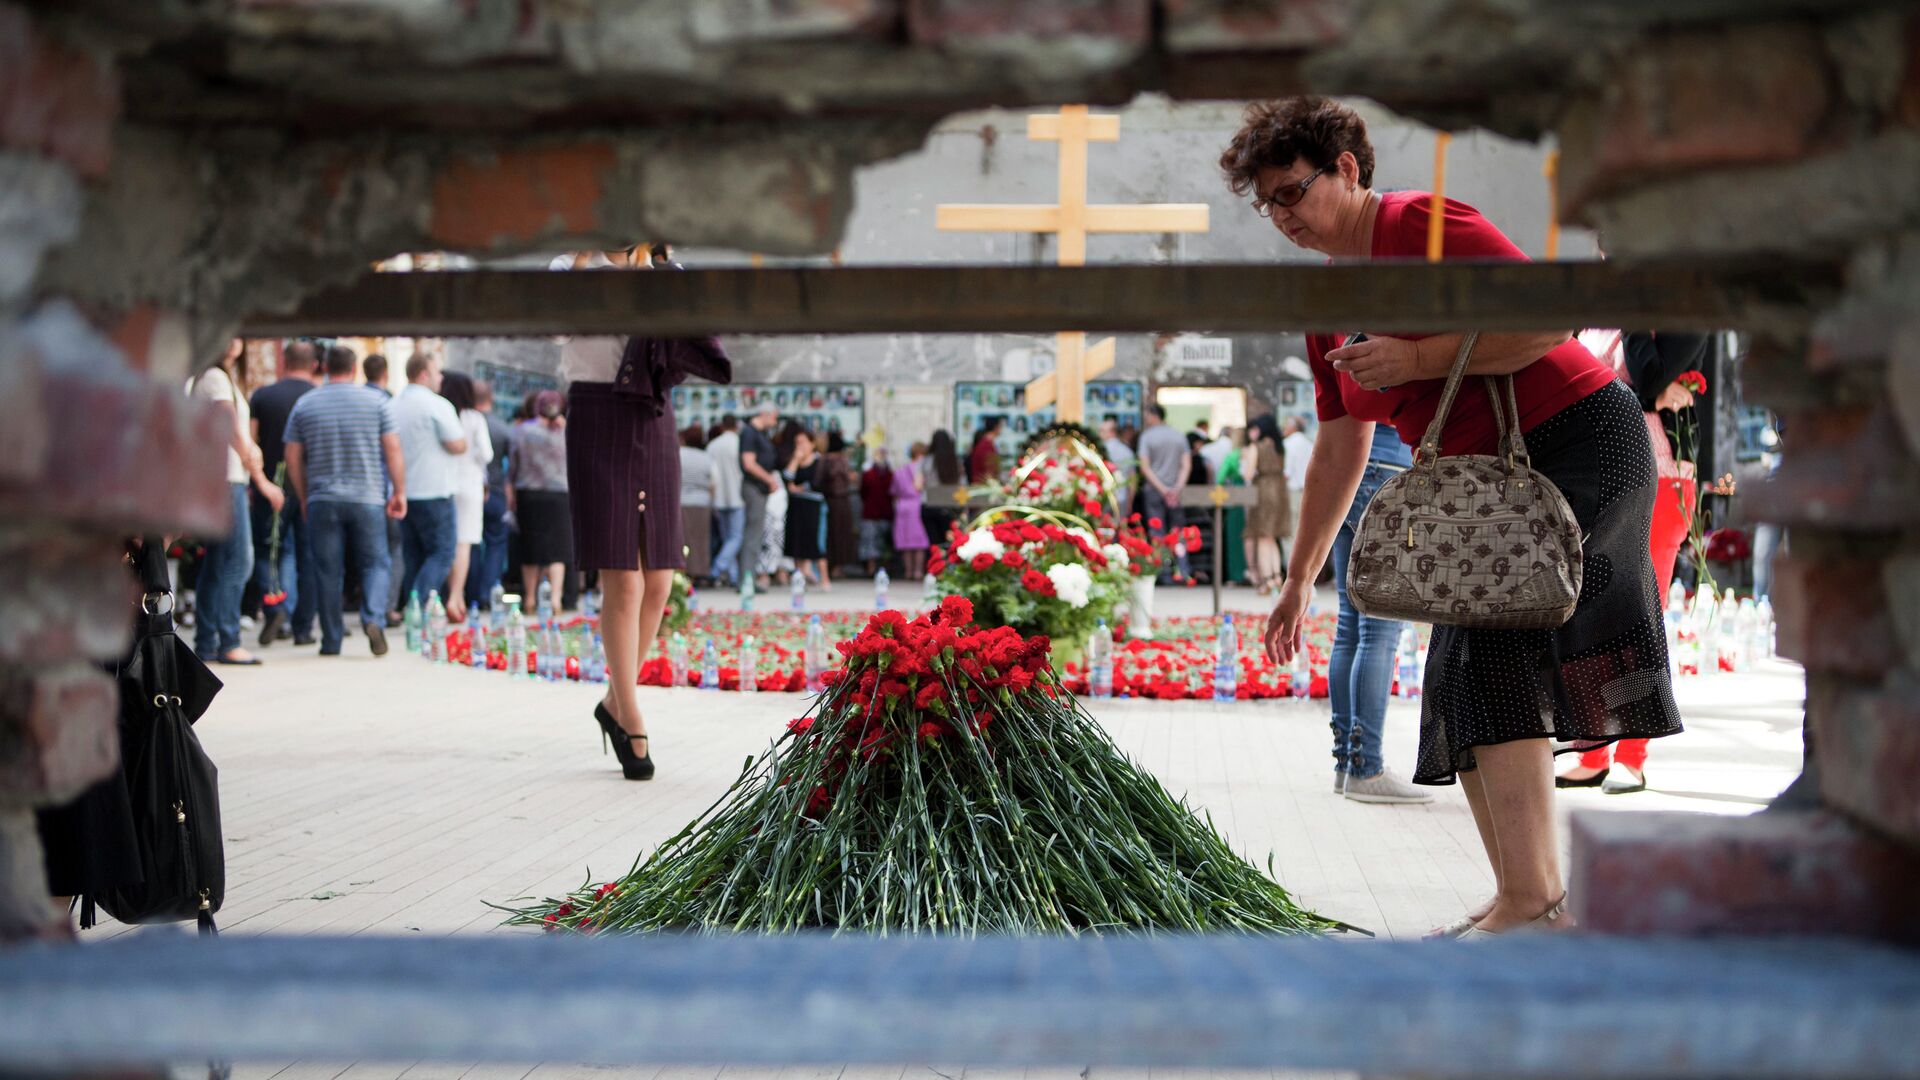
[933,106,1208,423]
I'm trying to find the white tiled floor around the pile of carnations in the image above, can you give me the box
[116,582,1803,1080]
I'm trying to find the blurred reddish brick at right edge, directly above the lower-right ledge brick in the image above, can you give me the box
[1807,673,1920,849]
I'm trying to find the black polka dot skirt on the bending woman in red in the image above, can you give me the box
[1413,382,1680,784]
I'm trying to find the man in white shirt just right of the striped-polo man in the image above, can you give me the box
[394,354,467,603]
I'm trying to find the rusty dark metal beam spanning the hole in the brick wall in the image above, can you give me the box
[242,259,1839,336]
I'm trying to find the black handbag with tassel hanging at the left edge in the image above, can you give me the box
[81,540,227,934]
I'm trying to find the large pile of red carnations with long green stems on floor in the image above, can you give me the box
[507,598,1338,934]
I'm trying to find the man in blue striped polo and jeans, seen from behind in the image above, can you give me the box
[286,346,407,655]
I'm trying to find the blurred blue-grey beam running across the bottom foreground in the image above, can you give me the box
[0,934,1920,1080]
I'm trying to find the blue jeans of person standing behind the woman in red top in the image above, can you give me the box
[1327,463,1400,778]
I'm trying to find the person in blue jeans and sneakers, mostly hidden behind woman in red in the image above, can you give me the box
[1327,425,1434,803]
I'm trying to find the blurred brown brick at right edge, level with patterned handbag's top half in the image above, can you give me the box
[1747,402,1920,532]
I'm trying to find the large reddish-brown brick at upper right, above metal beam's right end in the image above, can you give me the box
[1561,23,1836,215]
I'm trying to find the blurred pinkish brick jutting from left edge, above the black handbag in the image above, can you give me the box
[0,304,232,536]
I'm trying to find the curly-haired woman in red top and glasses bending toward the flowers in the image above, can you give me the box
[1221,98,1680,936]
